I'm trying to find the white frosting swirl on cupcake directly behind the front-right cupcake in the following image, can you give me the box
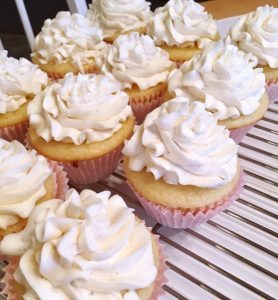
[168,41,265,120]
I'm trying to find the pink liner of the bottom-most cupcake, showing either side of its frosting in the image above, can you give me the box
[0,235,166,300]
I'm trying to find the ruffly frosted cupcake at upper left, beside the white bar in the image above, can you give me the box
[31,11,106,79]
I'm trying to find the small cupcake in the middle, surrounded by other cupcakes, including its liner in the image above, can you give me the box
[101,32,174,124]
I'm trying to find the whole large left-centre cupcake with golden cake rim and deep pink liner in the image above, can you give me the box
[27,73,134,184]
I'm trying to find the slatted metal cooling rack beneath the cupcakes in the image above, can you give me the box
[2,101,278,300]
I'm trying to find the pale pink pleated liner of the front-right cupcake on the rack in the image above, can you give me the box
[128,171,244,228]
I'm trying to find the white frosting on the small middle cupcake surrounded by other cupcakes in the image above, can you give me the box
[102,32,174,90]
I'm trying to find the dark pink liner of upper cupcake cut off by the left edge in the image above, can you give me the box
[0,121,29,144]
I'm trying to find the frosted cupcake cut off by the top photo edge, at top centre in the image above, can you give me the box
[87,0,152,43]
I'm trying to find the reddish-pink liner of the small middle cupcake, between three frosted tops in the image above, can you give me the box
[129,89,166,124]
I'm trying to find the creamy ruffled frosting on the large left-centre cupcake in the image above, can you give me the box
[28,73,132,145]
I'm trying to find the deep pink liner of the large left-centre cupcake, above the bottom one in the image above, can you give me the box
[59,145,123,187]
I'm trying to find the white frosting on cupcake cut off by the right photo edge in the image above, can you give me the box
[230,5,278,68]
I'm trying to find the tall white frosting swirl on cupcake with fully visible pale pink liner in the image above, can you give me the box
[123,97,238,188]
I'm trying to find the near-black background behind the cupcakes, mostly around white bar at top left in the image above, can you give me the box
[0,0,207,58]
